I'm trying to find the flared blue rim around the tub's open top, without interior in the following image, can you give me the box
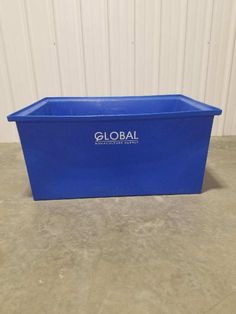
[7,94,222,122]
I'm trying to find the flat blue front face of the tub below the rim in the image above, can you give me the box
[17,116,213,199]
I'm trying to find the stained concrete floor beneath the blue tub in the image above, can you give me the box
[0,137,236,314]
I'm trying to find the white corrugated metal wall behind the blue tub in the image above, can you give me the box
[0,0,236,142]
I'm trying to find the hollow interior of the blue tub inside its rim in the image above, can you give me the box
[30,99,206,116]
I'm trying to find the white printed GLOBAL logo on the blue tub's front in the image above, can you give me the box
[94,131,139,145]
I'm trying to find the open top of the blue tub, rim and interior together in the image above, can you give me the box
[8,95,221,121]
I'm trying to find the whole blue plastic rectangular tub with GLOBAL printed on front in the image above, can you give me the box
[8,95,221,200]
